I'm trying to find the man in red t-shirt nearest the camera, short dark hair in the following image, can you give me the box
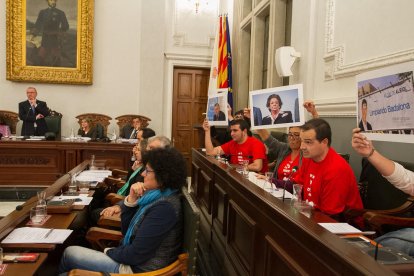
[294,119,363,215]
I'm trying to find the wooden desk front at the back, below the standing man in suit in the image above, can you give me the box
[0,140,134,187]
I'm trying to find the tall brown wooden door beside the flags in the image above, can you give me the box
[172,68,210,175]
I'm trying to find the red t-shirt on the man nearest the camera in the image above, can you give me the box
[294,148,363,215]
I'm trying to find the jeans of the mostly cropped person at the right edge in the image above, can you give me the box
[375,228,414,256]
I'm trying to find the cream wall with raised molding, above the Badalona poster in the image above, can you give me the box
[291,0,414,117]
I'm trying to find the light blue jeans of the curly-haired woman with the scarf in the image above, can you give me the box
[59,246,120,273]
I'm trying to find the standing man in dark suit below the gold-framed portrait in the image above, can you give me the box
[19,87,49,136]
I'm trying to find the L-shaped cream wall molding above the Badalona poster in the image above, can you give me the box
[324,0,414,80]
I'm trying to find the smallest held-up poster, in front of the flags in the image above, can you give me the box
[206,88,228,126]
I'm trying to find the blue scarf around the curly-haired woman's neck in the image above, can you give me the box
[122,188,178,245]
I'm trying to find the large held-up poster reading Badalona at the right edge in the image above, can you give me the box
[356,62,414,143]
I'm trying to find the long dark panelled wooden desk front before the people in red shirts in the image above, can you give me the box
[191,149,412,275]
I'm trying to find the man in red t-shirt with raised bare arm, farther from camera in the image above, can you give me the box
[203,120,267,172]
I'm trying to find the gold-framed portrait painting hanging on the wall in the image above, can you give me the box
[6,0,94,84]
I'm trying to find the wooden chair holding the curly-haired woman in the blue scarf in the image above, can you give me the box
[79,187,200,276]
